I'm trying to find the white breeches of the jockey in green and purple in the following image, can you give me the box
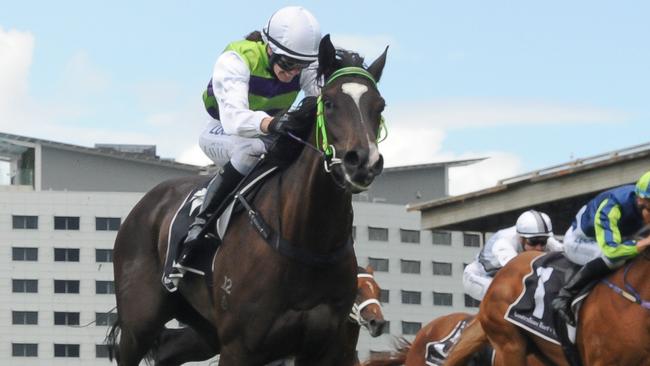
[199,119,270,174]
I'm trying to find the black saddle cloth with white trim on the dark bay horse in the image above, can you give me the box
[162,164,277,292]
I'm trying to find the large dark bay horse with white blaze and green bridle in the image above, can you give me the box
[109,36,386,366]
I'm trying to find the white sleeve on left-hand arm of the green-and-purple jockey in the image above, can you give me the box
[212,51,269,137]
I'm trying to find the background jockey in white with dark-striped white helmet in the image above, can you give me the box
[463,210,563,301]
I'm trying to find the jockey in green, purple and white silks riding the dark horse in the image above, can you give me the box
[174,6,321,277]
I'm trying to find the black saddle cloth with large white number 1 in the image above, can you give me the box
[505,252,592,345]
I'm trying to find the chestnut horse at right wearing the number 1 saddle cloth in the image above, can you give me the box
[446,250,650,366]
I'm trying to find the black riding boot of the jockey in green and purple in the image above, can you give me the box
[178,162,243,267]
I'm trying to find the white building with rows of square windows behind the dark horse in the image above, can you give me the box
[0,133,482,365]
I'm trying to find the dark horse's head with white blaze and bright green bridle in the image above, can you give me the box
[316,35,388,193]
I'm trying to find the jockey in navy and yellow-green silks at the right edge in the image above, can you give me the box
[552,171,650,326]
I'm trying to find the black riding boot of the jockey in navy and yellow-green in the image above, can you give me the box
[551,258,612,327]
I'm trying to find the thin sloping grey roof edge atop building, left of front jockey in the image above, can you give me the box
[0,132,202,172]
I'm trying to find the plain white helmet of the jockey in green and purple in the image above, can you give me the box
[262,6,321,62]
